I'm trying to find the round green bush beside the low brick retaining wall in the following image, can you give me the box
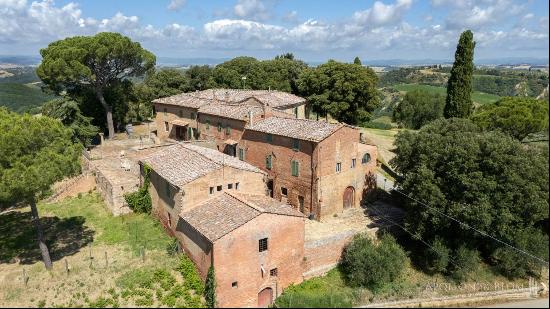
[340,234,408,291]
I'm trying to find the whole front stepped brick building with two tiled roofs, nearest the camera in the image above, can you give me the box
[140,144,305,307]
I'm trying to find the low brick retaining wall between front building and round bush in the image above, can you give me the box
[303,231,354,279]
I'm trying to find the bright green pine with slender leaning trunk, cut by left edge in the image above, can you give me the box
[0,108,81,269]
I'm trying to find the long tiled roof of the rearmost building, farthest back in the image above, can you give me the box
[153,89,306,109]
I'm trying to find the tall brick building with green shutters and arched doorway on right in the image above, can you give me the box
[242,117,377,220]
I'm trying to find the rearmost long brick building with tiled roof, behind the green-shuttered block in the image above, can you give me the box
[153,89,306,151]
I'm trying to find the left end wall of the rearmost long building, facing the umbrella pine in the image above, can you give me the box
[155,103,197,141]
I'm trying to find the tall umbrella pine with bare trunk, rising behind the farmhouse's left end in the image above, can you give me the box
[36,32,155,138]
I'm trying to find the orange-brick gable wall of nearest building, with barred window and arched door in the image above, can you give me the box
[214,214,304,308]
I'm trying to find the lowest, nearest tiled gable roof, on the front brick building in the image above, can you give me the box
[180,192,303,242]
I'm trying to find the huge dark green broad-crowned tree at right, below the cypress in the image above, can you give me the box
[390,118,549,276]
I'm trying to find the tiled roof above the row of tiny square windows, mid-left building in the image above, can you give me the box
[140,143,264,187]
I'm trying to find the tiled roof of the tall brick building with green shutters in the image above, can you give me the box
[246,117,343,142]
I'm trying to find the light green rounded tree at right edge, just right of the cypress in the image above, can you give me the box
[472,97,548,140]
